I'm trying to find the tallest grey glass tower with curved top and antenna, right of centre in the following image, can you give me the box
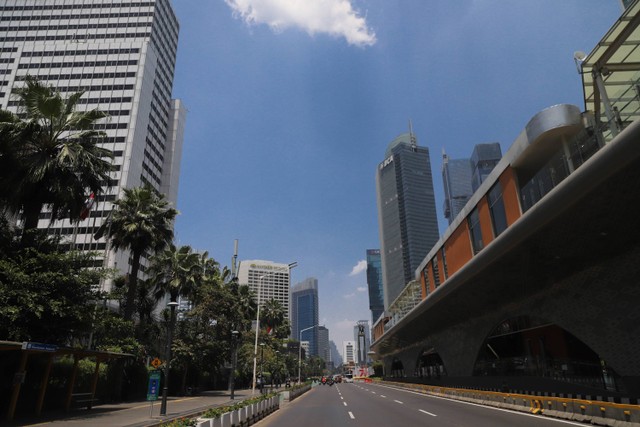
[376,132,439,308]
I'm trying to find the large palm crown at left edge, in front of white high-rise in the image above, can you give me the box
[0,76,113,234]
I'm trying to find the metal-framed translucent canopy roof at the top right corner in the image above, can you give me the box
[576,0,640,141]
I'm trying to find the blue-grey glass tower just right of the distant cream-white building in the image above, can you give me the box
[291,277,319,356]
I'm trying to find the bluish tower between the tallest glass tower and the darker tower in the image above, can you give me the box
[442,153,473,224]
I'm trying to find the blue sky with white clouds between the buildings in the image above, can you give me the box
[173,0,621,349]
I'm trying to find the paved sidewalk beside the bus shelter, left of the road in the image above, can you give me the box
[7,390,257,427]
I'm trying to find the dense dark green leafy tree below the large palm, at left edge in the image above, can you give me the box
[0,227,103,344]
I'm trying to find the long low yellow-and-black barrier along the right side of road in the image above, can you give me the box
[380,381,640,426]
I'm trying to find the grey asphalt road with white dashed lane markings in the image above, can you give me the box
[258,383,596,427]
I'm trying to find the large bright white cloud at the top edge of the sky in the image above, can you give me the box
[224,0,376,46]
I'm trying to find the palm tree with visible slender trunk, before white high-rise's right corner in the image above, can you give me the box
[94,186,178,320]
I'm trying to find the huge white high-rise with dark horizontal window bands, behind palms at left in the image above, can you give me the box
[0,0,186,290]
